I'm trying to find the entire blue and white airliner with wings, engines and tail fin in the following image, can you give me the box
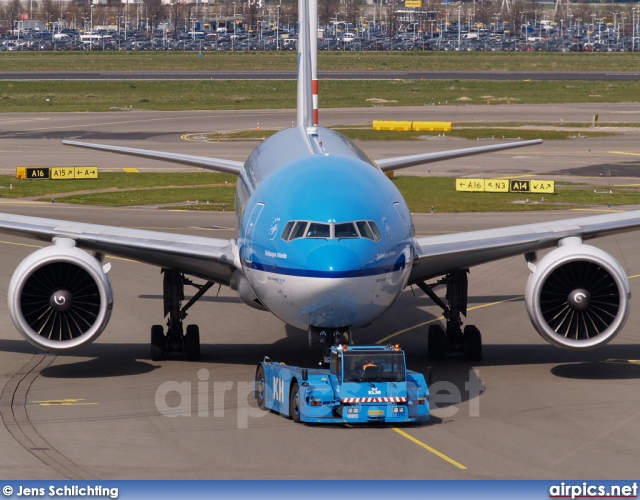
[0,0,640,360]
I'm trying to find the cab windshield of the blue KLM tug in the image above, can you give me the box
[344,351,405,382]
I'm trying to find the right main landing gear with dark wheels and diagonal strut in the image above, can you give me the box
[416,269,482,361]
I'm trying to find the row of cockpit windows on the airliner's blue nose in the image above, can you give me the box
[281,220,382,241]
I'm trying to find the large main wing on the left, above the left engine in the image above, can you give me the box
[0,214,235,285]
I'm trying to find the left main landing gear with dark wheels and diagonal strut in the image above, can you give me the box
[151,269,213,361]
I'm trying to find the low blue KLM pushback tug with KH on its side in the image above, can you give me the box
[255,345,429,424]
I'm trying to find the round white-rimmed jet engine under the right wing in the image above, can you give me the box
[525,238,631,350]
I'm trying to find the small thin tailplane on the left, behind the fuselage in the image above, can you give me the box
[62,141,243,175]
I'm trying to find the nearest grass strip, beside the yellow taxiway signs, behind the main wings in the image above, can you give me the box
[0,172,640,212]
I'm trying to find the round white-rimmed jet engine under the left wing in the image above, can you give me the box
[8,239,113,352]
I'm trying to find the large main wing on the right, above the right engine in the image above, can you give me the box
[409,210,640,284]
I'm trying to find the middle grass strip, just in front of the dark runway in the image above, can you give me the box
[0,79,640,111]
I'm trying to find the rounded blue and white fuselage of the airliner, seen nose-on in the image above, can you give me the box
[236,127,414,329]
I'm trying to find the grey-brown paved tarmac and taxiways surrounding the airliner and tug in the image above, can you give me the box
[0,105,640,479]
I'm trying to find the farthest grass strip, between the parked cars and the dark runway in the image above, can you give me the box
[0,51,640,72]
